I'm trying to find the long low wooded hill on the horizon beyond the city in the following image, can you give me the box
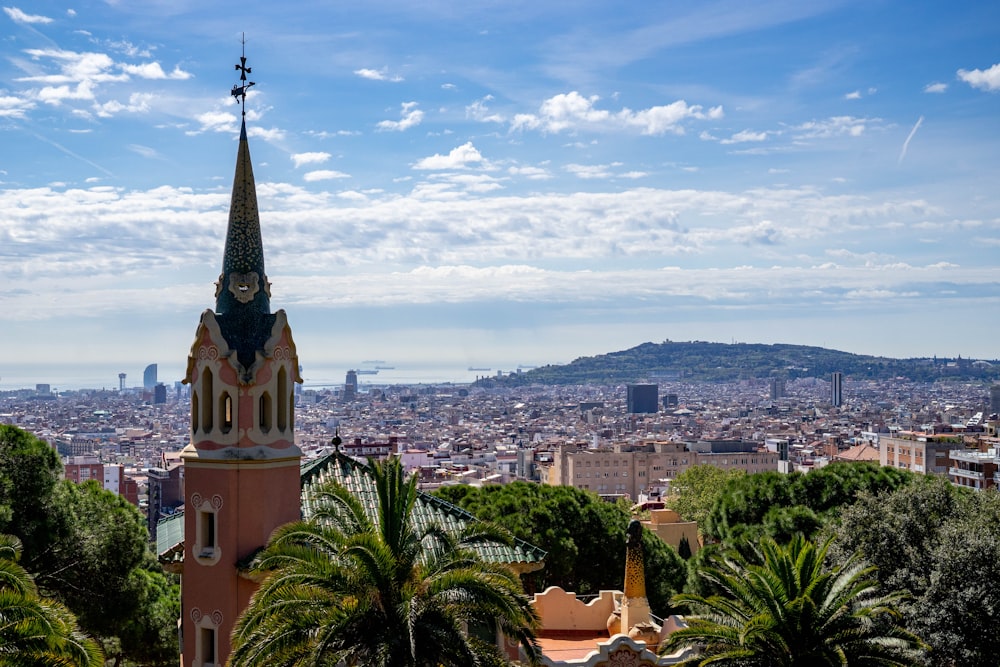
[487,340,1000,385]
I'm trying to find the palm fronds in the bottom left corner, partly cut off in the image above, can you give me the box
[0,535,104,667]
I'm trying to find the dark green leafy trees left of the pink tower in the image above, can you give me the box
[0,425,180,665]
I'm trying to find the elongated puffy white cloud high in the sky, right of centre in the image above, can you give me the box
[511,91,723,135]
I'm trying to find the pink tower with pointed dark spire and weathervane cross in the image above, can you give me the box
[181,52,302,667]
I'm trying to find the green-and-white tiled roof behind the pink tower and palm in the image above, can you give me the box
[156,452,545,570]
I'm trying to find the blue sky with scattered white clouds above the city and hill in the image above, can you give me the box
[0,0,1000,387]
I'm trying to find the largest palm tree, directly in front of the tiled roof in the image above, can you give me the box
[231,460,539,667]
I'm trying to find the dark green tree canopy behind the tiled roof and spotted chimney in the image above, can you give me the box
[435,482,686,616]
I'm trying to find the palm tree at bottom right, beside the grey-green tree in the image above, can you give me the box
[660,536,923,667]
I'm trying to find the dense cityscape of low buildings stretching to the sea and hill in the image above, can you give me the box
[0,366,1000,538]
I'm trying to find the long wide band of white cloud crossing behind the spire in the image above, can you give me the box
[0,179,984,347]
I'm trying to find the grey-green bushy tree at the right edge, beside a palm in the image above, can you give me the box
[831,478,1000,667]
